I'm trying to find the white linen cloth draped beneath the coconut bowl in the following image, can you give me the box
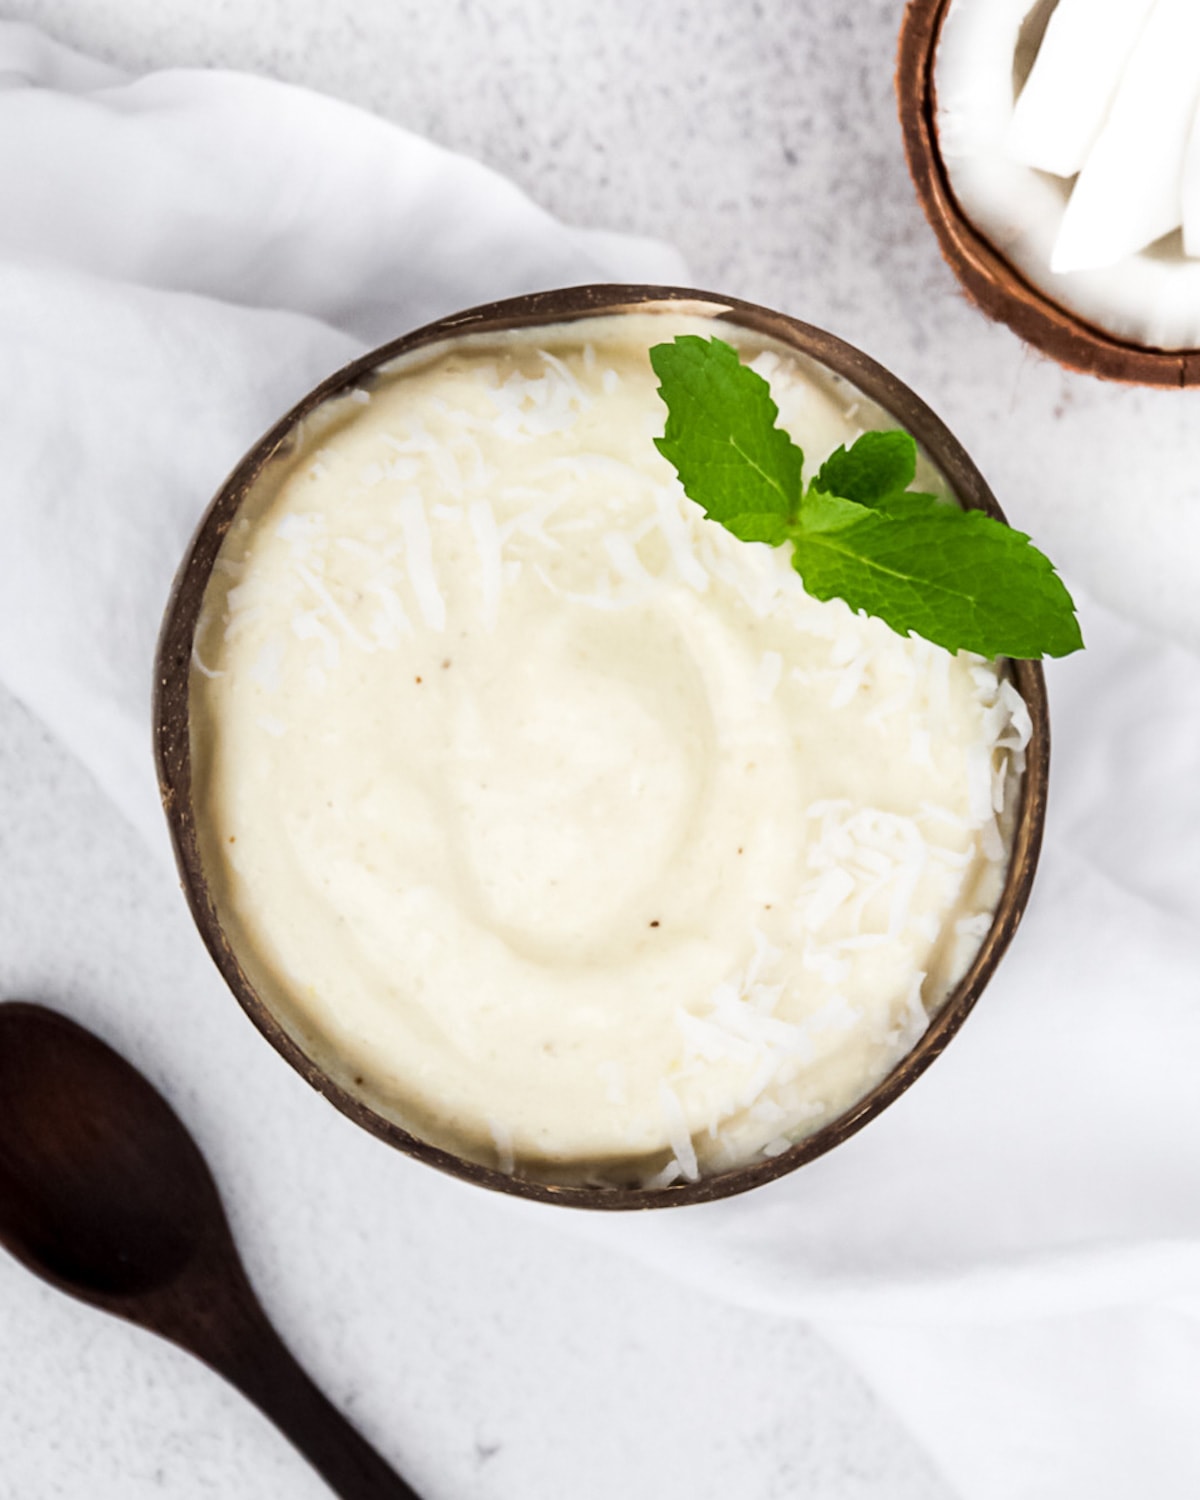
[0,24,1200,1500]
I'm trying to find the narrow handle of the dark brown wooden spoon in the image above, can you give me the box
[173,1268,422,1500]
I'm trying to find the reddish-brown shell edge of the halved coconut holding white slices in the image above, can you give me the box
[896,0,1200,389]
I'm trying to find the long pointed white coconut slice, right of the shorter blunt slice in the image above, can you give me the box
[1050,0,1200,272]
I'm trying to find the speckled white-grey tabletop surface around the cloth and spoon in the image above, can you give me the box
[0,0,1200,1500]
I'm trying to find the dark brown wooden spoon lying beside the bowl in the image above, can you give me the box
[0,1001,419,1500]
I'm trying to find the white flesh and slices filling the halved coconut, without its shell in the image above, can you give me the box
[935,0,1200,350]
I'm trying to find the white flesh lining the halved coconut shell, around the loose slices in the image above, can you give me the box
[935,0,1200,350]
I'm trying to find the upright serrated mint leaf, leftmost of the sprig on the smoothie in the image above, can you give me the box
[650,333,804,534]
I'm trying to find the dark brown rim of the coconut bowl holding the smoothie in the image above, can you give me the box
[153,285,1050,1209]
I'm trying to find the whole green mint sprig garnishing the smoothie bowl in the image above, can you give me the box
[650,343,1083,659]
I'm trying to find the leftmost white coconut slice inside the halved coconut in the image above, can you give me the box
[1008,0,1154,177]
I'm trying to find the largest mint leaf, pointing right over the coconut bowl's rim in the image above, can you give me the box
[791,489,1083,657]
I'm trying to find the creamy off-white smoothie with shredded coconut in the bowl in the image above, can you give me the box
[191,314,1029,1185]
